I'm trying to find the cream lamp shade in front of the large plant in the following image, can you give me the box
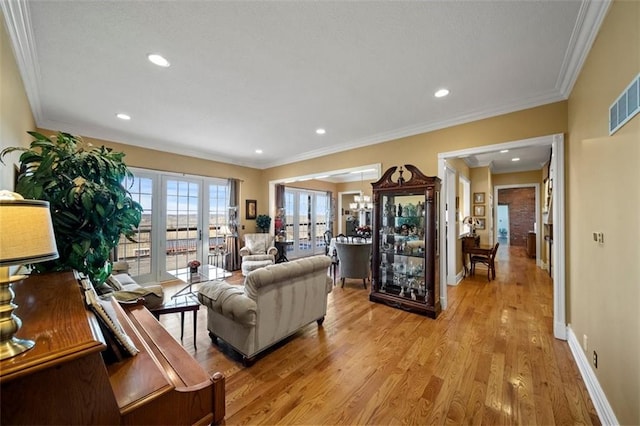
[0,191,58,266]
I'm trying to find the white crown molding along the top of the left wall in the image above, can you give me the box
[0,0,42,126]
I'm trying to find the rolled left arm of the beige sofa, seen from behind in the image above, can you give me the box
[198,281,257,327]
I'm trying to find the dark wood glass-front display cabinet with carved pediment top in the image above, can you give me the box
[369,164,441,318]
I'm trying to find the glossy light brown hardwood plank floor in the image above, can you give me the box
[161,247,600,425]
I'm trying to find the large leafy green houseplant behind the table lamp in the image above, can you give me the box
[0,132,142,285]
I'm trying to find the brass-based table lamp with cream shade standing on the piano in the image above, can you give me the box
[0,190,58,360]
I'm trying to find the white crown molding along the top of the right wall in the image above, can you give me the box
[556,0,611,99]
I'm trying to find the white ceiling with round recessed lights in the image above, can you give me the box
[0,0,609,172]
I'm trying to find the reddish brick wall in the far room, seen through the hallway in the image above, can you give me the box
[498,188,536,247]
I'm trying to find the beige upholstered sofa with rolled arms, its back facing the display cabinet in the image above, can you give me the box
[198,256,333,365]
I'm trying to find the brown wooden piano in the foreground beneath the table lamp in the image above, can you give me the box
[0,272,225,425]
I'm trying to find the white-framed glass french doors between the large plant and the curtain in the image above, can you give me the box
[115,169,230,282]
